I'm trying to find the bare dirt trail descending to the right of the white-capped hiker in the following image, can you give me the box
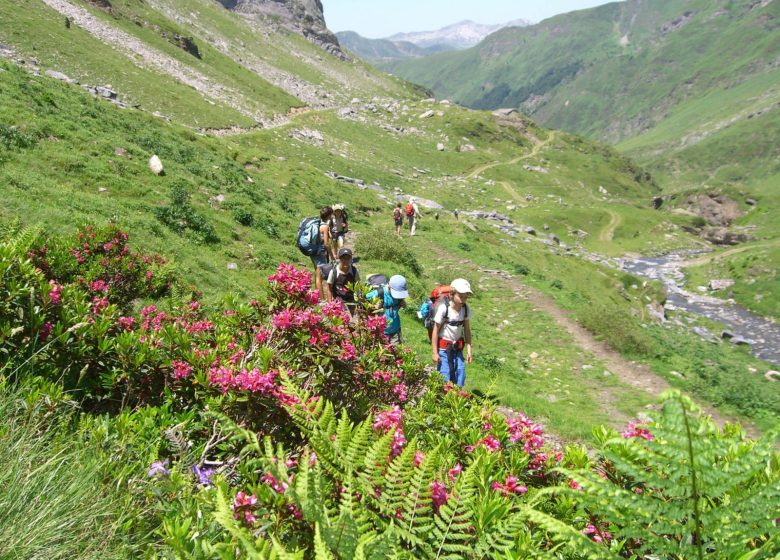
[430,246,761,438]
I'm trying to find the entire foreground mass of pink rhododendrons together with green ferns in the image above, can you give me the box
[0,227,780,559]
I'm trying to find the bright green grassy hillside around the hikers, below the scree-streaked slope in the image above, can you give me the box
[6,55,774,438]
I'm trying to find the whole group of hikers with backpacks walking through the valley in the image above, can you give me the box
[296,202,473,387]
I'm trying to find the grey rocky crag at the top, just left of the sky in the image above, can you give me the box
[219,0,348,60]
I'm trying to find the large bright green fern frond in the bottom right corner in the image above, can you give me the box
[566,393,780,558]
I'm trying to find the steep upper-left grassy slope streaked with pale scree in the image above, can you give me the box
[0,0,414,128]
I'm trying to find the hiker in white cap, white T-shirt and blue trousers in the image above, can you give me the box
[431,278,473,387]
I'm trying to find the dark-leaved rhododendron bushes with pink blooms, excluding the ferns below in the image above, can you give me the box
[2,227,422,431]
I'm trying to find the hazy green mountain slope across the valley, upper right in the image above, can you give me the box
[383,0,780,190]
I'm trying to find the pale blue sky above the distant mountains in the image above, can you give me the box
[322,0,608,39]
